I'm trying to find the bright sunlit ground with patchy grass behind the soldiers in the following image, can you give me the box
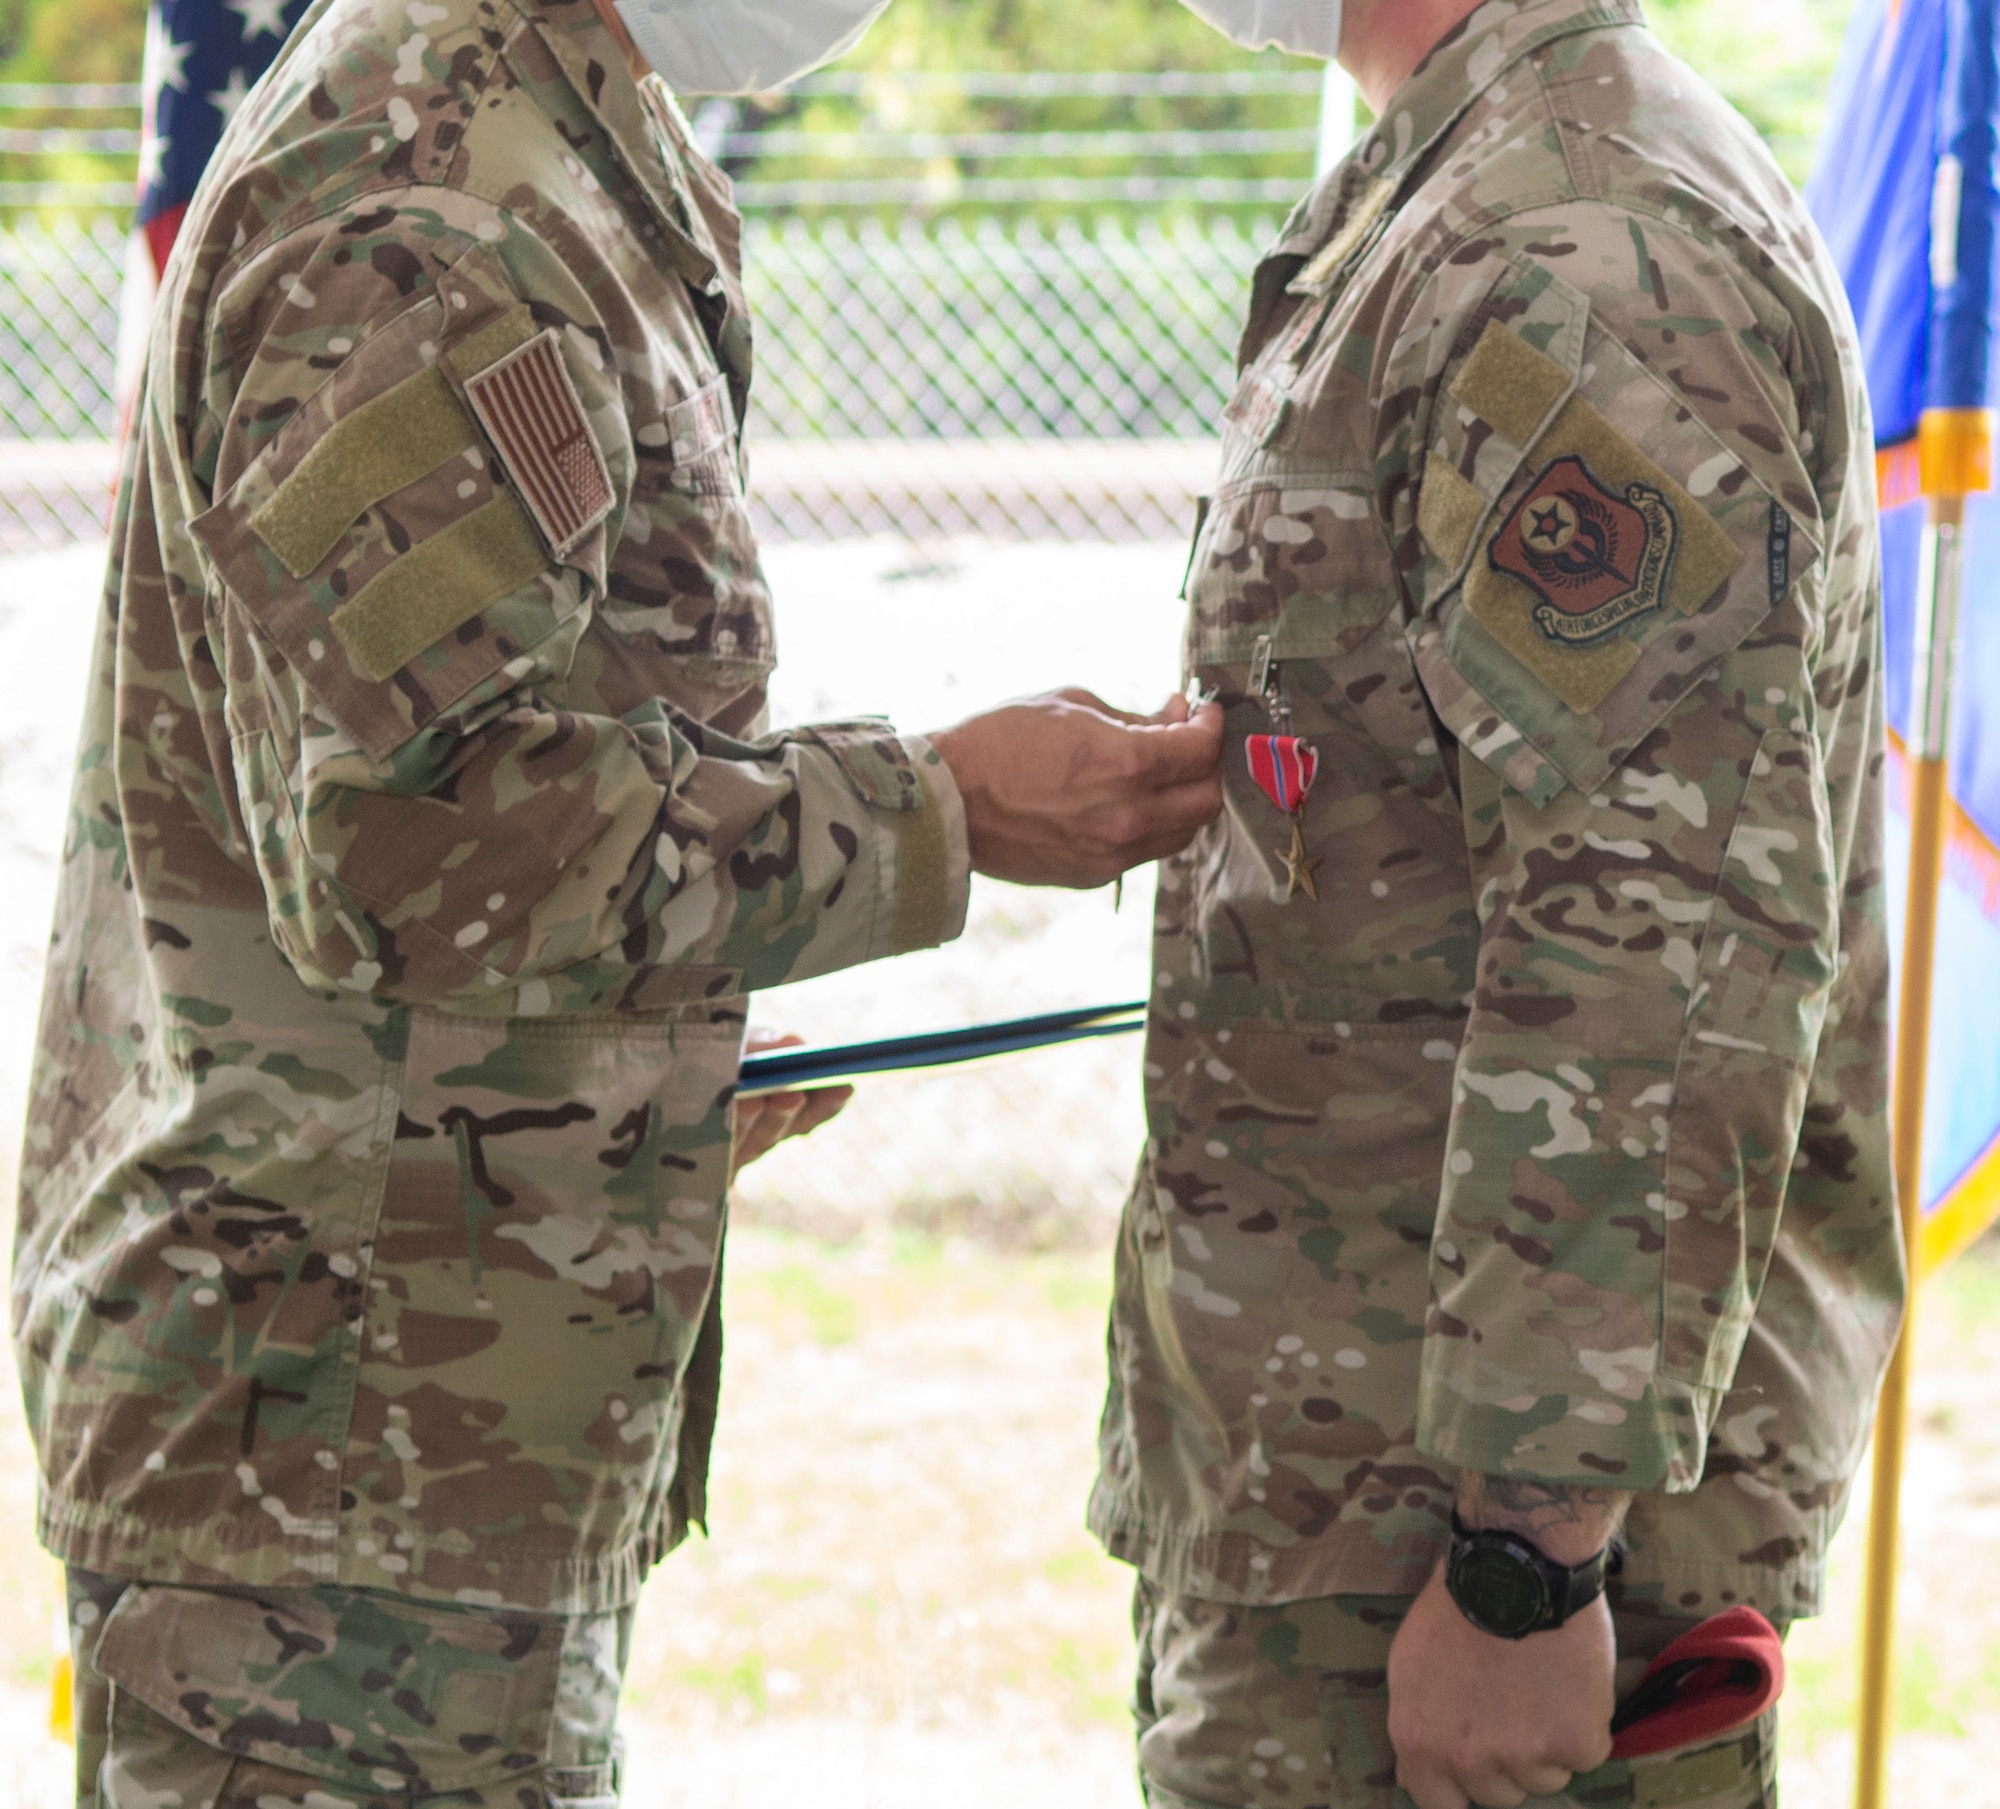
[0,542,2000,1809]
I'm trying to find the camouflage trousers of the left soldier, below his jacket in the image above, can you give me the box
[70,1569,632,1809]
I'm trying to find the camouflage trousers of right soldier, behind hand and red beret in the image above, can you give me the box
[1132,1577,1778,1809]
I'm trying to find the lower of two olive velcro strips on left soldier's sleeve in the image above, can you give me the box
[332,494,552,678]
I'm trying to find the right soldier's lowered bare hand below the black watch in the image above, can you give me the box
[1388,1563,1618,1809]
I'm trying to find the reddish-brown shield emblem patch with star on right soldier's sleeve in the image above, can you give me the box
[1486,454,1678,646]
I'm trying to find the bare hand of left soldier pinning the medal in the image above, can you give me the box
[930,690,1222,886]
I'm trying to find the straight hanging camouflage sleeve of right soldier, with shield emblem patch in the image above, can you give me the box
[1406,206,1874,1491]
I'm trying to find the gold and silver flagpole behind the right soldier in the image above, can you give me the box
[1854,408,1994,1809]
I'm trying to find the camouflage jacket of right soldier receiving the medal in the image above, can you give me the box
[1092,0,1904,1617]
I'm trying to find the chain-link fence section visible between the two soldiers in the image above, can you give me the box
[746,216,1260,540]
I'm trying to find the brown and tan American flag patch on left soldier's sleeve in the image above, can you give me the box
[466,328,612,558]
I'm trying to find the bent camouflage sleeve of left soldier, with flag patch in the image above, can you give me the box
[194,198,970,1013]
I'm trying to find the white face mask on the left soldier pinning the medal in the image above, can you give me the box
[612,0,888,94]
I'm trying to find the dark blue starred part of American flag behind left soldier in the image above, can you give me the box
[138,0,308,274]
